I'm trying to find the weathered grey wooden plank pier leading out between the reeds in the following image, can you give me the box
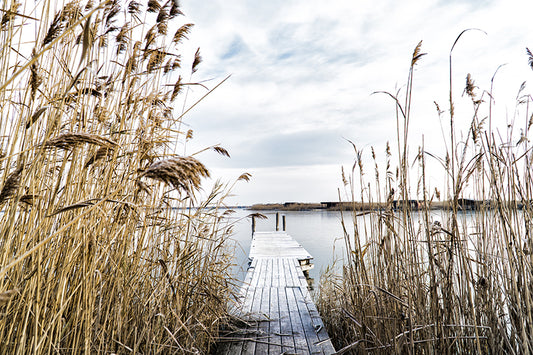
[218,232,335,355]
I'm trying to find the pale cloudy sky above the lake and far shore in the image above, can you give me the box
[176,0,533,205]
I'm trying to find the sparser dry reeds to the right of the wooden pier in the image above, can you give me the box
[317,33,533,354]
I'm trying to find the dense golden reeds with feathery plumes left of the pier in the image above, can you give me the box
[0,0,239,354]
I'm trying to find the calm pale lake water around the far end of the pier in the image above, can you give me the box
[222,210,504,287]
